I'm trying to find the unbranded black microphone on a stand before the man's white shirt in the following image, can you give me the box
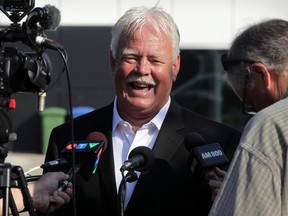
[120,146,155,172]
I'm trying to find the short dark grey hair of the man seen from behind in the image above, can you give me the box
[227,19,288,89]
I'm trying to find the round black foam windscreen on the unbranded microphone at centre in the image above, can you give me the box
[128,146,155,172]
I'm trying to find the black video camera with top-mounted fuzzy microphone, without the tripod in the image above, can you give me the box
[0,0,61,96]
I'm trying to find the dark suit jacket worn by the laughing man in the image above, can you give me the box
[38,100,240,216]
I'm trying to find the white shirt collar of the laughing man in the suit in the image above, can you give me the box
[112,96,171,132]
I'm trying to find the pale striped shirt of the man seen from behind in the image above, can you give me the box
[209,97,288,216]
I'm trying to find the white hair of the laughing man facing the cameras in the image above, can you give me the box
[110,6,180,60]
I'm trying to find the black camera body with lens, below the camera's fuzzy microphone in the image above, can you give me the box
[0,47,51,95]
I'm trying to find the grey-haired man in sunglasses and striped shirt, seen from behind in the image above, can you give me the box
[209,19,288,216]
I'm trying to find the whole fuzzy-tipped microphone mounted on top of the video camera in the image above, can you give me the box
[28,4,61,30]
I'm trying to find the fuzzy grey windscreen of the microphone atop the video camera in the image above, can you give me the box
[39,4,61,30]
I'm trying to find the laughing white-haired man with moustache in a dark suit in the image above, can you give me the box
[38,3,240,216]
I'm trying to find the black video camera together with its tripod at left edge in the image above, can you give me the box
[0,0,64,216]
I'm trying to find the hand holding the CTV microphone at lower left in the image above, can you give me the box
[28,172,73,212]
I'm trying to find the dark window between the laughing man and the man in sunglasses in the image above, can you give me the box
[172,50,248,130]
